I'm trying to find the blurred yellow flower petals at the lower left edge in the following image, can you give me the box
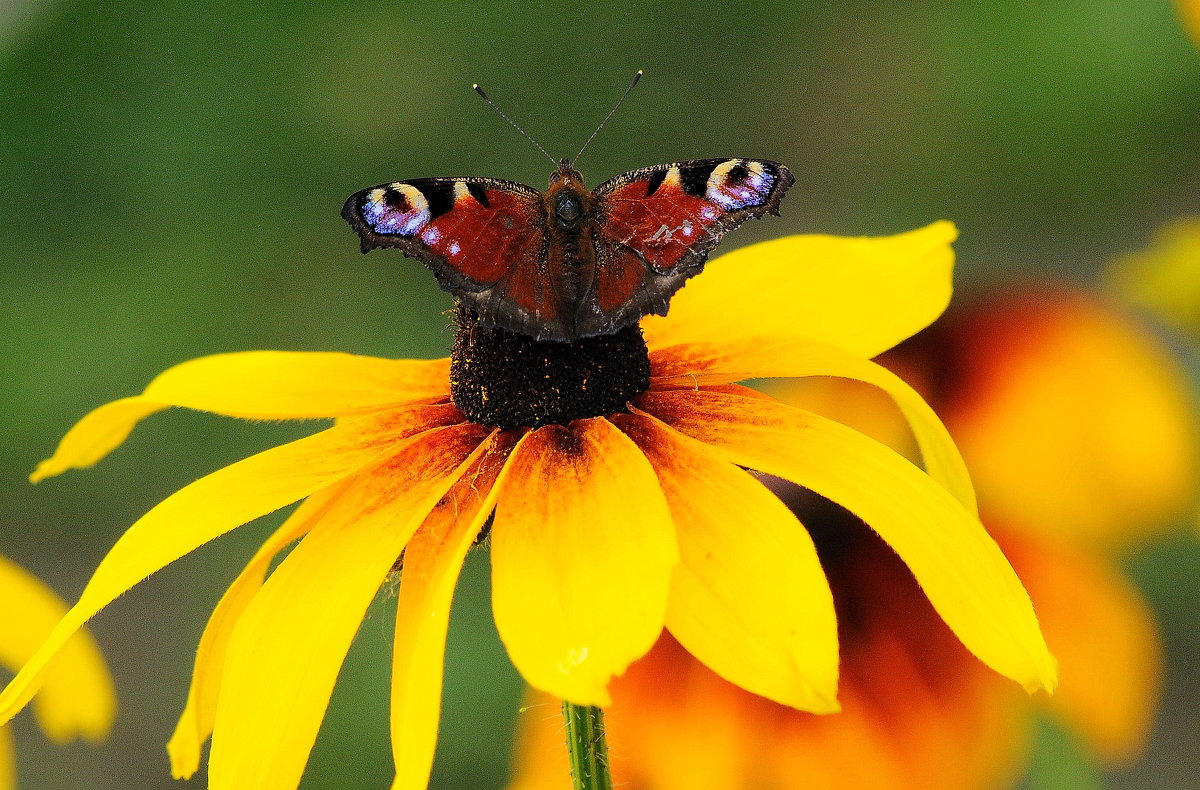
[0,549,116,790]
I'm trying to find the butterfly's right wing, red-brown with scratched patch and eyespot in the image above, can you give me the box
[578,158,794,334]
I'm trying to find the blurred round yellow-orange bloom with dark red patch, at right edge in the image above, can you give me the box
[912,288,1196,546]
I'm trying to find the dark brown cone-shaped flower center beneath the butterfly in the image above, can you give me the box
[450,305,650,430]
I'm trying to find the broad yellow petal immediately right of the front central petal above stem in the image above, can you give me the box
[614,417,838,713]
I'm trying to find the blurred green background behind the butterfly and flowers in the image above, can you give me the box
[0,0,1200,790]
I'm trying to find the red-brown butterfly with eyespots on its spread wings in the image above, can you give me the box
[342,158,793,342]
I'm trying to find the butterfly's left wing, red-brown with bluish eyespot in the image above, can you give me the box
[342,178,578,336]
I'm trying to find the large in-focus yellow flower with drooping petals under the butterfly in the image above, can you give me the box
[0,222,1055,790]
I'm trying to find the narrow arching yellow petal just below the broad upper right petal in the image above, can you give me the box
[650,340,976,513]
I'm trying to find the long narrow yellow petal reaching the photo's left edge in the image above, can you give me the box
[0,407,454,723]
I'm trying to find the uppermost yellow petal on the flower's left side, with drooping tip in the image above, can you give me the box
[30,351,450,483]
